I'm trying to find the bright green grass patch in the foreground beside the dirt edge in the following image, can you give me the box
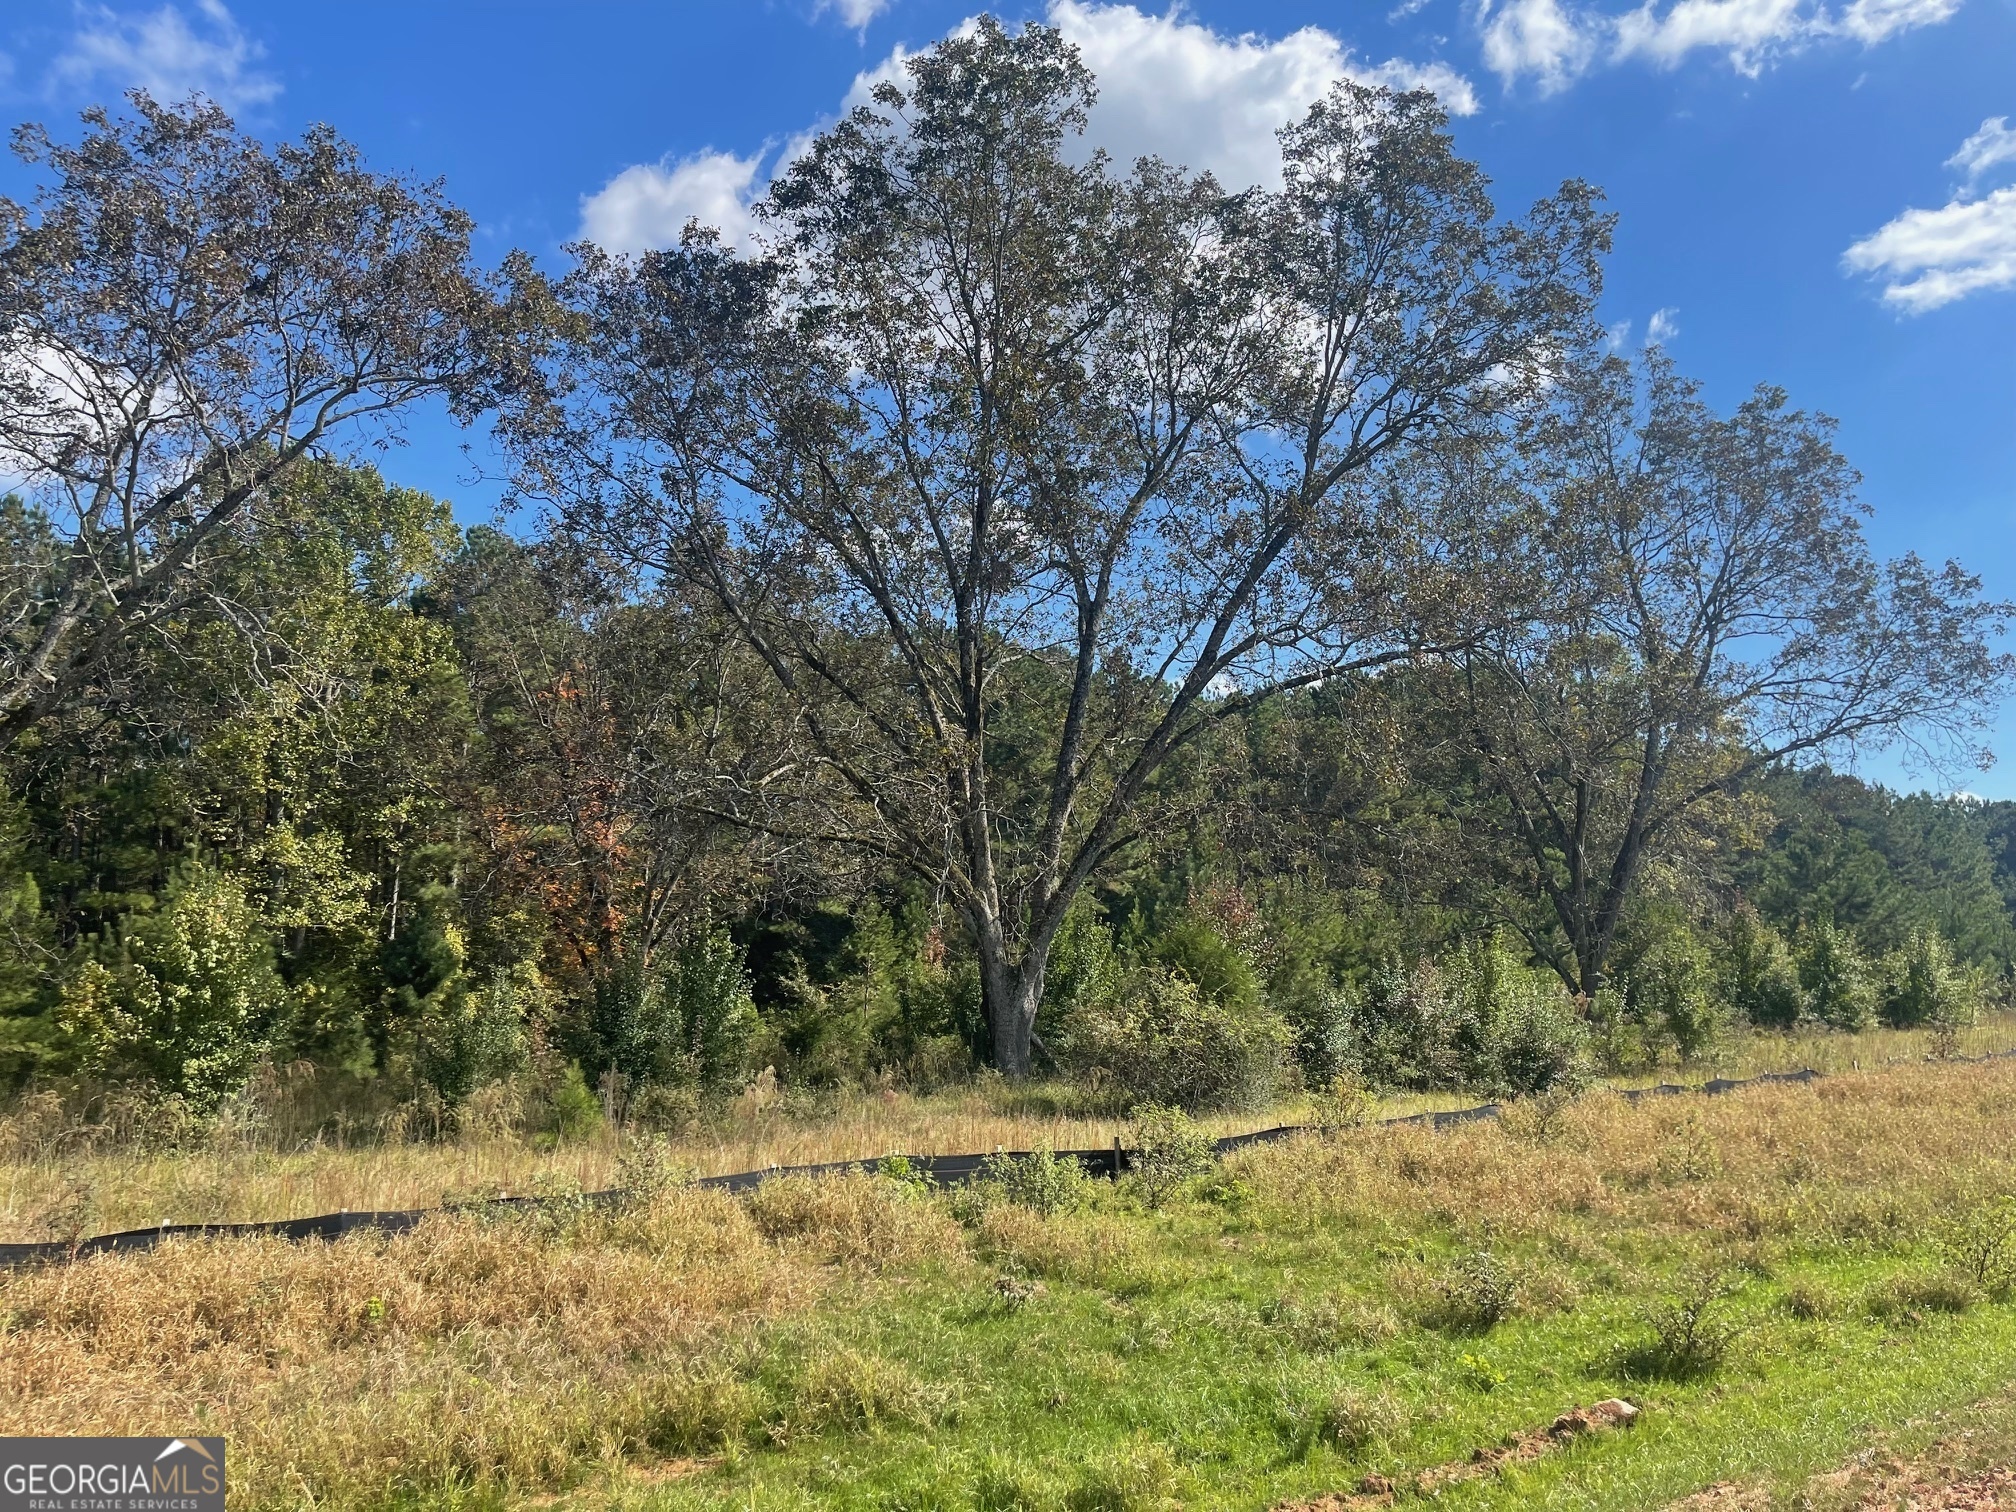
[600,1161,2016,1512]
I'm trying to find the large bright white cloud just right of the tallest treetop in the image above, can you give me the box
[1048,0,1478,187]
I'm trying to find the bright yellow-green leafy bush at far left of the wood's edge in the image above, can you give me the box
[56,867,292,1113]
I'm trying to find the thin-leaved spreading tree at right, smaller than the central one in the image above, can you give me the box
[1441,353,2016,994]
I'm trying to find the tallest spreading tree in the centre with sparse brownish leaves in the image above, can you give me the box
[510,20,1609,1075]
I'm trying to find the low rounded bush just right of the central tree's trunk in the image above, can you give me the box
[1062,968,1290,1109]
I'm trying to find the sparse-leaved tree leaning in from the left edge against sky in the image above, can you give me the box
[0,95,528,742]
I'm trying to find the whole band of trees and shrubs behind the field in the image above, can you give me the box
[0,22,2016,1129]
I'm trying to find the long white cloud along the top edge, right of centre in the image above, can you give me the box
[1476,0,1962,93]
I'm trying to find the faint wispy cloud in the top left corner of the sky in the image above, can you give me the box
[50,0,280,111]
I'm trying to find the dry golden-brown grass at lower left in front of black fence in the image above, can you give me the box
[0,1179,960,1506]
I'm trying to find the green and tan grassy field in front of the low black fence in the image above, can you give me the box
[0,1046,2016,1512]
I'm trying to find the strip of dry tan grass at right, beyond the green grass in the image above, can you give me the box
[1234,1060,2016,1242]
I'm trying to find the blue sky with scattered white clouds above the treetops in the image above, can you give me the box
[0,0,2016,796]
